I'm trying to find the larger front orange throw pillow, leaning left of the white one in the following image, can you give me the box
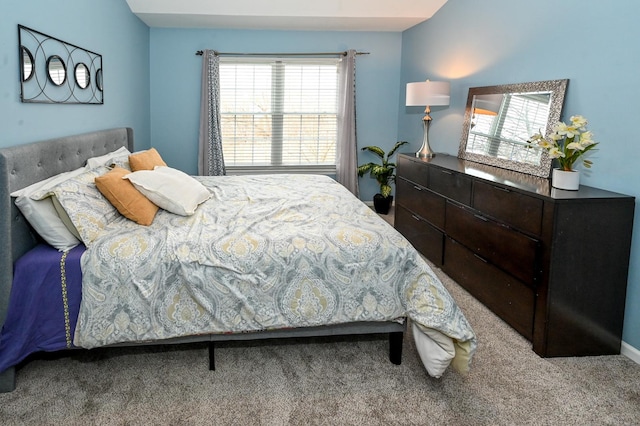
[95,167,159,226]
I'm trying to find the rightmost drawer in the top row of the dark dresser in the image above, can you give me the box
[473,181,544,235]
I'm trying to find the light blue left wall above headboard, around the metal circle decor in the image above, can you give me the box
[0,0,150,148]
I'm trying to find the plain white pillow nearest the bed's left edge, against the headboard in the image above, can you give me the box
[11,167,85,251]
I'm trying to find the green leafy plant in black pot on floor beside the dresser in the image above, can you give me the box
[358,141,408,214]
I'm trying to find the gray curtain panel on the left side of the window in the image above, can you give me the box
[198,50,226,176]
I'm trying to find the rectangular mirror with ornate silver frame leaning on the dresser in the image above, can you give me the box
[458,80,569,177]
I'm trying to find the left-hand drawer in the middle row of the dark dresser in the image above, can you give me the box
[396,178,446,229]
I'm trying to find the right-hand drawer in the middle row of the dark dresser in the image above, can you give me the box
[445,202,539,285]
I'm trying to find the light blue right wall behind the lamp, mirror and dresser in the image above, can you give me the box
[398,0,640,349]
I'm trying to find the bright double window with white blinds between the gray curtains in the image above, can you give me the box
[220,57,339,174]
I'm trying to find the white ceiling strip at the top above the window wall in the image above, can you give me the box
[126,0,447,31]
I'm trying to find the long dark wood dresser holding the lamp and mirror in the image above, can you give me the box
[395,154,635,357]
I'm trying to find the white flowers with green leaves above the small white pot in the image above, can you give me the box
[529,115,598,171]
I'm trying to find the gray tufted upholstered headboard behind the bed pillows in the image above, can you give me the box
[0,128,133,386]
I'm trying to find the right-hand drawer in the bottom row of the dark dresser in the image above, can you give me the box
[442,238,535,340]
